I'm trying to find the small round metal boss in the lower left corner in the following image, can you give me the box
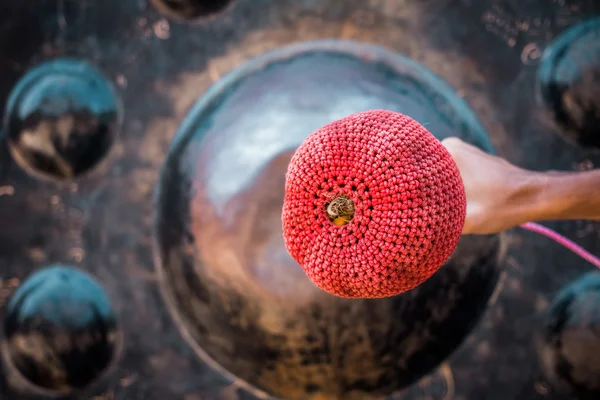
[2,265,123,395]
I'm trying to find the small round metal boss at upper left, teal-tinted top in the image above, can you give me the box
[4,59,122,179]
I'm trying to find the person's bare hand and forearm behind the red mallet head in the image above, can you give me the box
[442,138,600,234]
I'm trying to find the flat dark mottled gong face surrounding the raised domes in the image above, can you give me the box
[0,0,600,400]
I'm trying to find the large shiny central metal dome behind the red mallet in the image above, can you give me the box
[156,41,502,400]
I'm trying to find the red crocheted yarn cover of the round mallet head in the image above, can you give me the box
[282,110,466,298]
